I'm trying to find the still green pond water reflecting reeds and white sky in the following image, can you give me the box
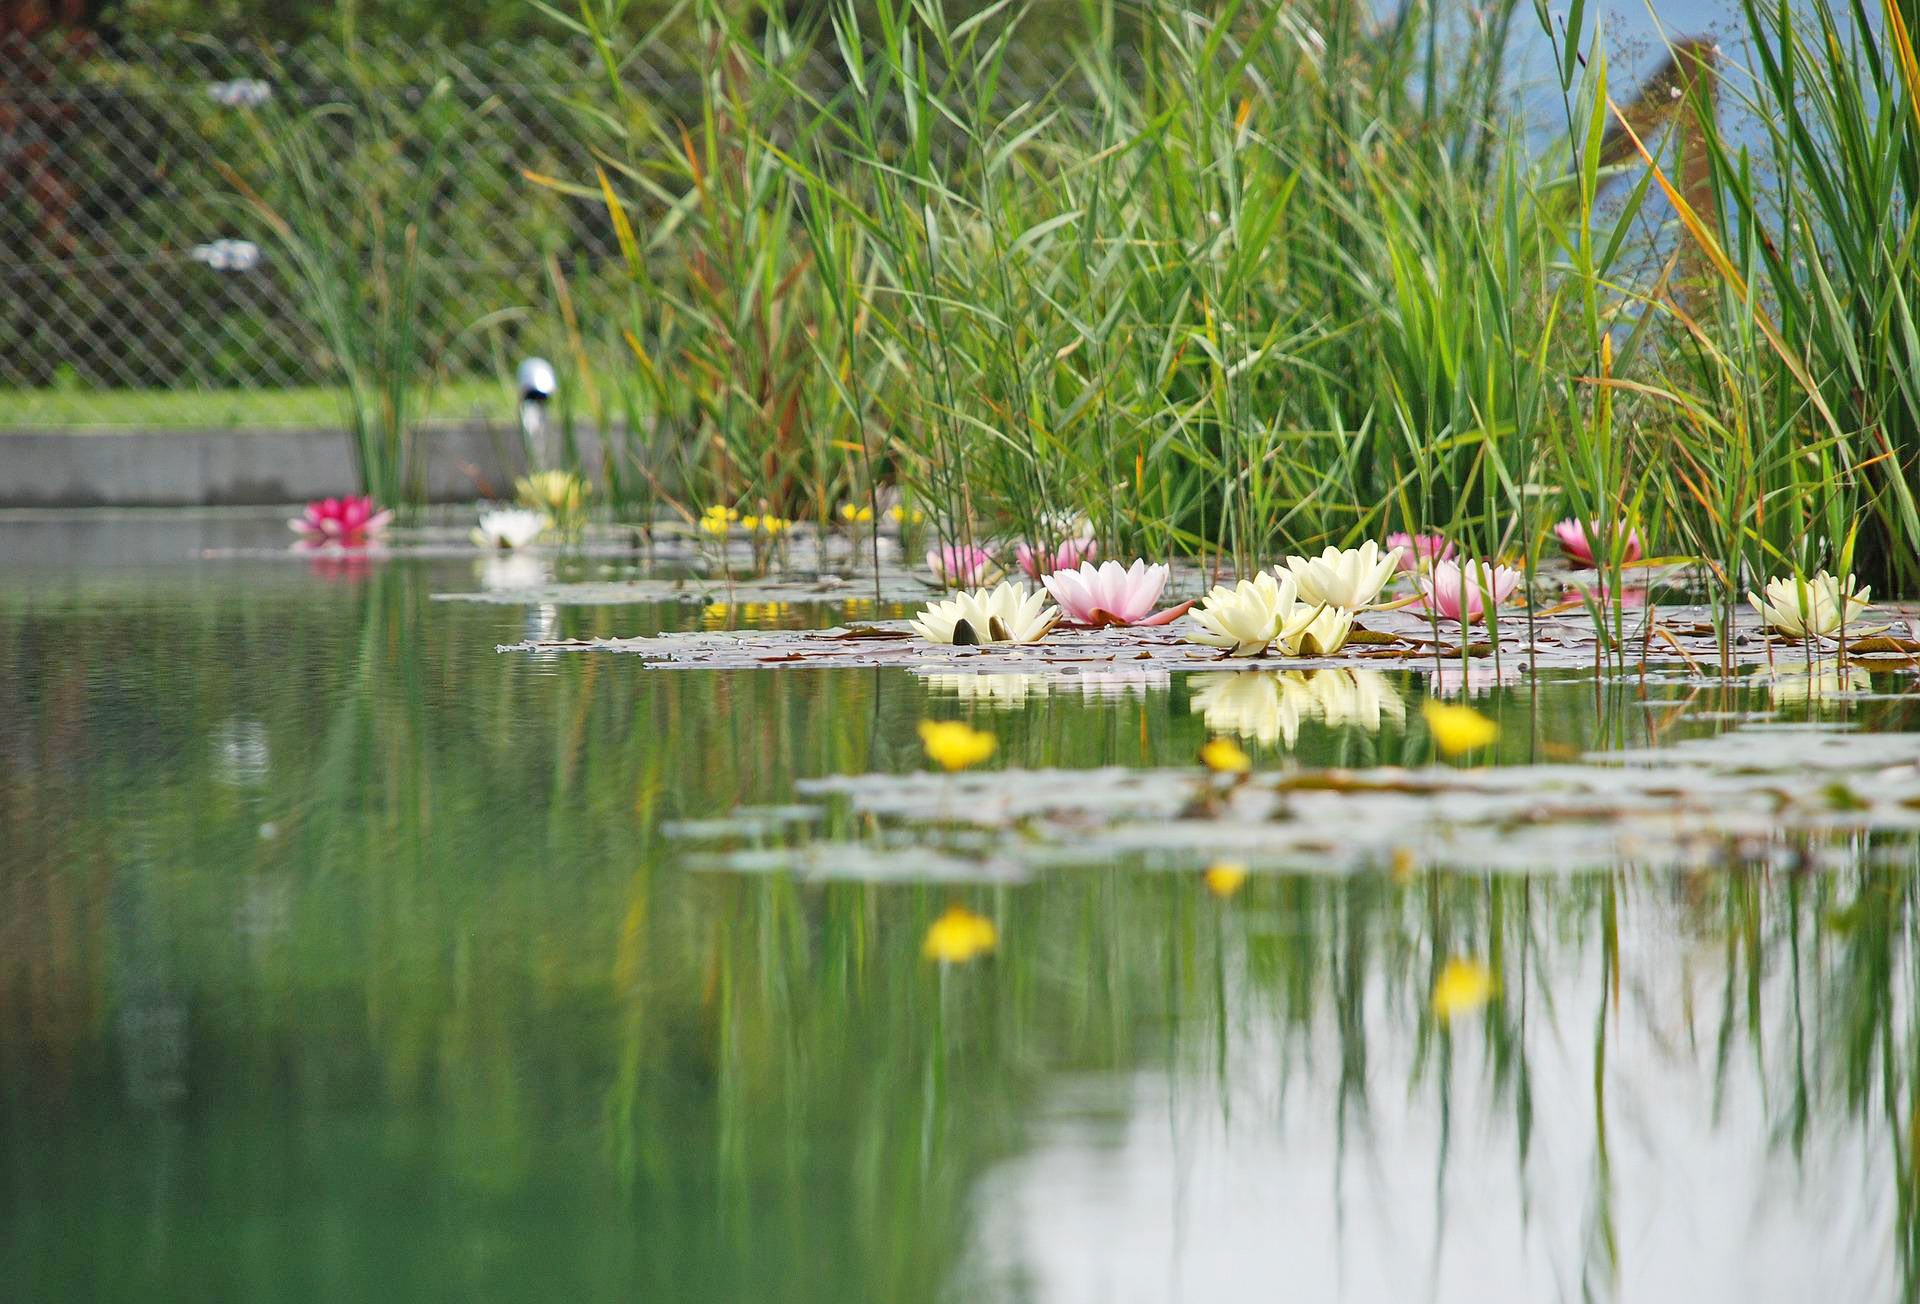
[0,519,1920,1300]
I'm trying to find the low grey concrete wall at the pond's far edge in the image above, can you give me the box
[0,424,599,507]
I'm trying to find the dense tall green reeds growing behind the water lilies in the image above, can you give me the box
[522,0,1920,603]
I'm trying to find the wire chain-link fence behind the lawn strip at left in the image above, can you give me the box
[0,38,699,428]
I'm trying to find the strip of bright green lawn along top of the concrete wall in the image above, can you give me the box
[0,380,513,432]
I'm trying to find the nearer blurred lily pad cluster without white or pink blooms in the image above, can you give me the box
[664,726,1920,878]
